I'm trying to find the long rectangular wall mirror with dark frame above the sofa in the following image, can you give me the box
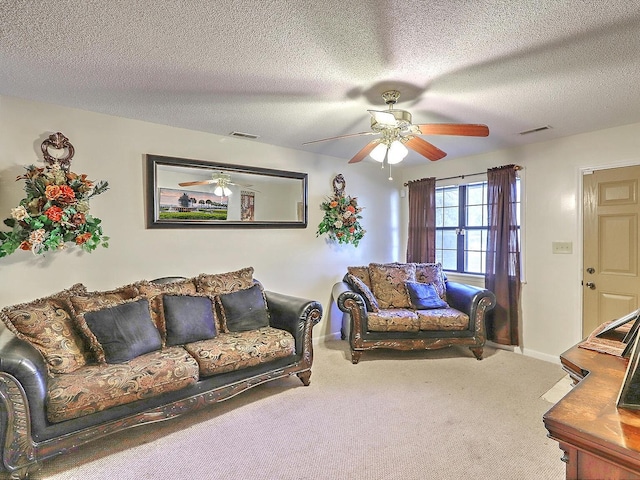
[146,155,307,228]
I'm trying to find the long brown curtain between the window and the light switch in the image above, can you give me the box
[485,165,520,345]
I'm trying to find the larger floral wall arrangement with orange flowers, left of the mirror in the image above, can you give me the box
[0,132,109,257]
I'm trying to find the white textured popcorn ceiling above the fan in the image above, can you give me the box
[0,0,640,165]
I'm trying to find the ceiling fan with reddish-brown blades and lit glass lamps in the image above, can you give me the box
[303,90,489,167]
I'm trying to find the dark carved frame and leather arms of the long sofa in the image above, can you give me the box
[0,291,322,479]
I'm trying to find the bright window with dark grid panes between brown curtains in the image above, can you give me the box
[436,180,520,274]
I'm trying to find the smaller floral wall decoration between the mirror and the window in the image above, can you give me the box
[316,174,366,247]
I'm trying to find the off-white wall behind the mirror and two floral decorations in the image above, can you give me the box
[0,96,400,338]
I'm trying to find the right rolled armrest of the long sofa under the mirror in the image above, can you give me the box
[264,290,322,355]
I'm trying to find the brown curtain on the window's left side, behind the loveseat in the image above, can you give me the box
[407,177,436,263]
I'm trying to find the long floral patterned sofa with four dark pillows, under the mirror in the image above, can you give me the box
[0,267,322,478]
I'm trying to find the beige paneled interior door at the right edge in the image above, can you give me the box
[582,166,640,337]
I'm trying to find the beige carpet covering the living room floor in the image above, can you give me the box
[12,341,564,480]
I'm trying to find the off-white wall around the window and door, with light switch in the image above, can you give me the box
[401,124,640,361]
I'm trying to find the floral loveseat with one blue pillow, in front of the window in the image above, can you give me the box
[333,263,496,363]
